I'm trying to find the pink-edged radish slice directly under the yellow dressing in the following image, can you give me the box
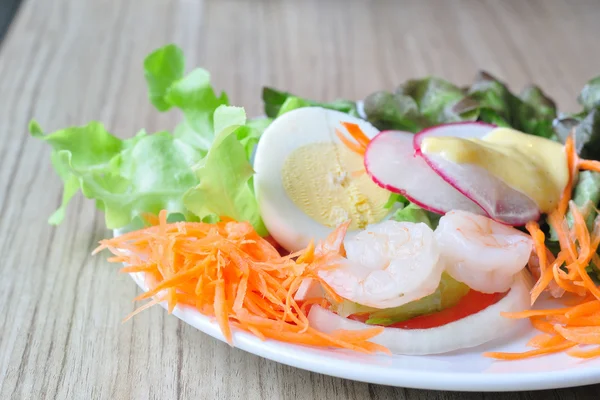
[413,122,540,226]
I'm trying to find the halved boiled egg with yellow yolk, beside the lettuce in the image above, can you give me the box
[254,107,390,251]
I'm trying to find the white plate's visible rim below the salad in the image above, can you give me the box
[131,274,600,392]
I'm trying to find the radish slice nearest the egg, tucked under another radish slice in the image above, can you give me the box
[365,131,485,214]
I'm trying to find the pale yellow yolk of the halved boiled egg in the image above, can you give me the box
[281,143,389,229]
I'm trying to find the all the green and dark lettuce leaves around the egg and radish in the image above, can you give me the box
[29,45,600,253]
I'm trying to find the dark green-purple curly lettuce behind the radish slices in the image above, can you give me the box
[364,71,556,137]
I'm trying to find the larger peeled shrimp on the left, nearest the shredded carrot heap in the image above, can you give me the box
[318,221,443,308]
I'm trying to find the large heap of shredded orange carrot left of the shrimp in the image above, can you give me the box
[95,211,388,353]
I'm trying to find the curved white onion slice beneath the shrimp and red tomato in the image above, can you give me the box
[308,272,530,355]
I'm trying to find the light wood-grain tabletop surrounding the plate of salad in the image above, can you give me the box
[0,0,600,399]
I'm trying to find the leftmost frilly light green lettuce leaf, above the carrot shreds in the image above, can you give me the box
[30,121,199,229]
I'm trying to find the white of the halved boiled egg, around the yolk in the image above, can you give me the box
[254,107,379,251]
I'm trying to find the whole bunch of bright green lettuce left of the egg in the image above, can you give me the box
[29,45,270,234]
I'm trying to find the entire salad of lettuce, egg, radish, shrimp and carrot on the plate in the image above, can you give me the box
[34,45,600,360]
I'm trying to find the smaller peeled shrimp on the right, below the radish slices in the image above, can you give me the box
[435,211,533,293]
